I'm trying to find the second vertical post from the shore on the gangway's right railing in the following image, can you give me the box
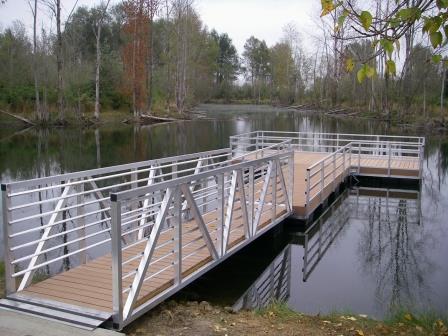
[173,187,182,285]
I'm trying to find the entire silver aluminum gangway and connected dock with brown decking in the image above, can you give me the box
[0,131,425,329]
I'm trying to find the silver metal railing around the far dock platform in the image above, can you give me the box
[230,131,425,217]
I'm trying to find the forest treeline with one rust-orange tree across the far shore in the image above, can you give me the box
[0,0,446,123]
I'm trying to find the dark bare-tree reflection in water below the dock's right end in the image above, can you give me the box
[356,190,434,311]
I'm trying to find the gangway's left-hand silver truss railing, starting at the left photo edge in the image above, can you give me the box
[2,149,236,294]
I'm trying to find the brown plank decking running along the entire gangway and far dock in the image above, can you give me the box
[15,152,419,313]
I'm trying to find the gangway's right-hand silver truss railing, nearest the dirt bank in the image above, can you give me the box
[111,144,293,328]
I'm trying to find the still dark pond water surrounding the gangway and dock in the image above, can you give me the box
[0,105,448,318]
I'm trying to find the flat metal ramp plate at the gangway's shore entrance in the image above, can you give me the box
[0,294,112,330]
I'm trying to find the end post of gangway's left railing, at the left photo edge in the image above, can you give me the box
[2,184,17,295]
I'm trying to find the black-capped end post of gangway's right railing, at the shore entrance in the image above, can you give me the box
[111,194,123,329]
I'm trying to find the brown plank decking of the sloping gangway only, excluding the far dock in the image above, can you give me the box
[22,180,286,313]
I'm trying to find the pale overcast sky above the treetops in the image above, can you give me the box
[0,0,320,53]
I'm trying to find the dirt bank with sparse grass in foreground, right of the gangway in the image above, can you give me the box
[125,302,448,336]
